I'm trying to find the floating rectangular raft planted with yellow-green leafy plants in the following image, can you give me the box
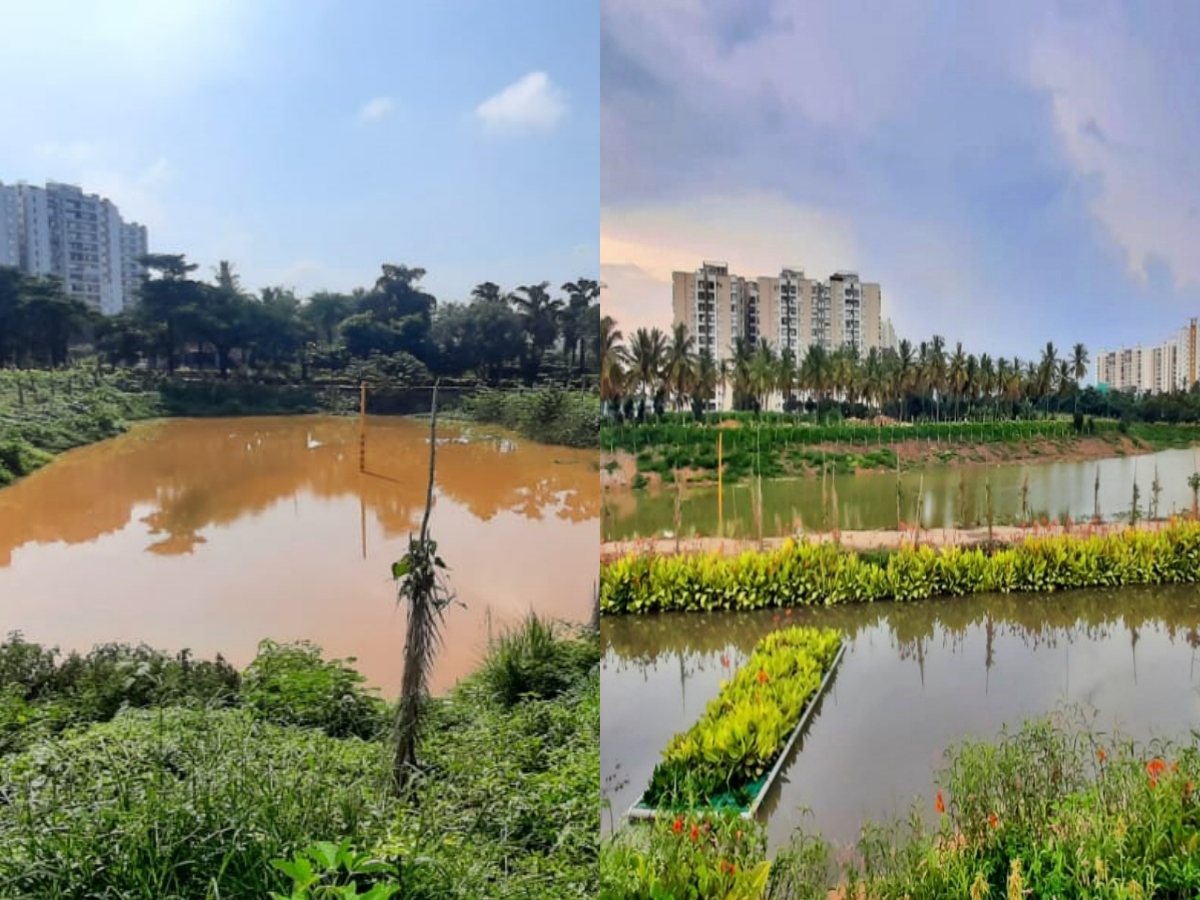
[626,628,846,820]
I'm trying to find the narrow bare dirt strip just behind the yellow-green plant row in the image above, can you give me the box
[600,520,1169,563]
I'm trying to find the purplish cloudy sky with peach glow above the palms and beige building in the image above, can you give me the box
[600,0,1200,374]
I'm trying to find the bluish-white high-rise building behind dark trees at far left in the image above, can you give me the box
[0,181,148,316]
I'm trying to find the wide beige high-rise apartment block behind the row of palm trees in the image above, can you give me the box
[672,263,883,360]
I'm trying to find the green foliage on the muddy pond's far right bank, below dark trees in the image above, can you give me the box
[463,388,600,448]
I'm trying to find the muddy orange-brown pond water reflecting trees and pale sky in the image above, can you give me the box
[0,416,600,695]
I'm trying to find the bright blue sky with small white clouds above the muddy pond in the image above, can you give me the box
[0,0,600,300]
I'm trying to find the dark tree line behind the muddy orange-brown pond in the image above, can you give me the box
[0,259,600,384]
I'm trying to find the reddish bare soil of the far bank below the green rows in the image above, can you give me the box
[600,434,1153,491]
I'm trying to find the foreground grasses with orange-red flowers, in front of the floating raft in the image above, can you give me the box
[599,710,1200,900]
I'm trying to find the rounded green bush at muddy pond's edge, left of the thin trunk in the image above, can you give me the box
[240,641,386,738]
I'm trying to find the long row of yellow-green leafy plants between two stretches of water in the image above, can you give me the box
[600,521,1200,614]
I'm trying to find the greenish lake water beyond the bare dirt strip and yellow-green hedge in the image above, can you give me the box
[602,450,1200,540]
